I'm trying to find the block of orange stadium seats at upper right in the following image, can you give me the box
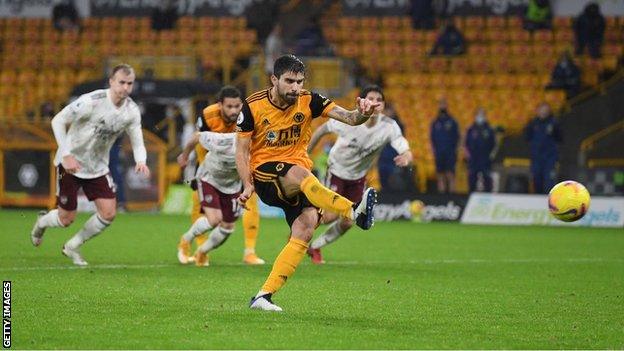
[323,16,624,182]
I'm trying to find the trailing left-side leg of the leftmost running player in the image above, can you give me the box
[30,166,80,246]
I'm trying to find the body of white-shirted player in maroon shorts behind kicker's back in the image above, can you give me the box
[178,132,243,267]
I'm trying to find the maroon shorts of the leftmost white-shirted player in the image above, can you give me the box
[56,165,117,211]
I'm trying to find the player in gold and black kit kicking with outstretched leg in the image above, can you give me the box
[236,55,378,311]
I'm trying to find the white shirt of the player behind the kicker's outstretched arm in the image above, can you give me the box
[327,115,409,180]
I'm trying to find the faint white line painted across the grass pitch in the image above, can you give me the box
[0,257,624,272]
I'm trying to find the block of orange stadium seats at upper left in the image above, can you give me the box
[0,17,257,120]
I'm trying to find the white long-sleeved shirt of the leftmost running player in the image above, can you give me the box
[52,89,147,179]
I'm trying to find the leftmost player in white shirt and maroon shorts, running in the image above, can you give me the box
[31,64,150,266]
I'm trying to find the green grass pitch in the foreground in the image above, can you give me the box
[0,210,624,349]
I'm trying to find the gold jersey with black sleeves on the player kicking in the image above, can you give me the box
[237,89,335,170]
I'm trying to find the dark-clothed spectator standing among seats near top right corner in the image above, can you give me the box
[574,2,605,58]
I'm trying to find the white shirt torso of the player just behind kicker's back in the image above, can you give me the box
[196,132,243,194]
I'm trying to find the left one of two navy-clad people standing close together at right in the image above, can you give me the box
[431,98,459,193]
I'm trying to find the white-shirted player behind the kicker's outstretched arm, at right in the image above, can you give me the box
[307,85,413,264]
